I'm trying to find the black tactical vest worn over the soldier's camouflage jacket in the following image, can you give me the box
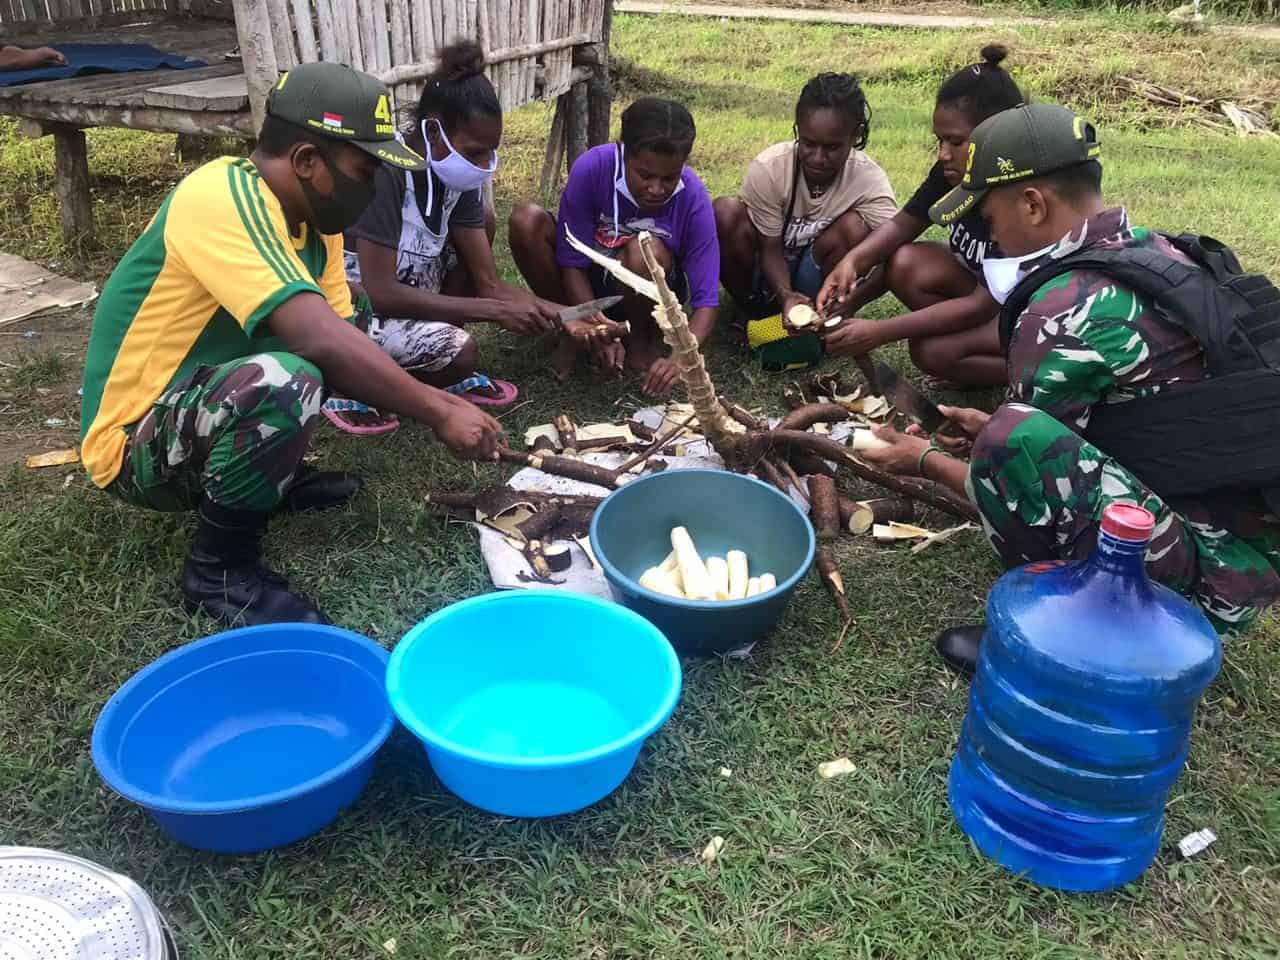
[1000,234,1280,512]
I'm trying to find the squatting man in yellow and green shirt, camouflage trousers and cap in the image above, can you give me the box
[81,63,502,623]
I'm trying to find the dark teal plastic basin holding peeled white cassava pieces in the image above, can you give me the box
[591,470,815,654]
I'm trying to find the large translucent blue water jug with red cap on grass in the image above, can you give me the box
[950,503,1222,891]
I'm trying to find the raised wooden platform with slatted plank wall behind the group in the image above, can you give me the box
[0,0,612,241]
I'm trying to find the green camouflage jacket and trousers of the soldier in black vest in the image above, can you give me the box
[969,209,1280,632]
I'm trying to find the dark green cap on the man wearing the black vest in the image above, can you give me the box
[929,104,1102,227]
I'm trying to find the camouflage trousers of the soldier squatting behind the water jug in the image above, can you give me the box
[968,403,1280,634]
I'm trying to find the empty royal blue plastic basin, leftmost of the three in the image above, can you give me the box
[93,623,396,854]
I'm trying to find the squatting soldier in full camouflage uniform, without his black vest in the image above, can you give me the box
[863,105,1280,673]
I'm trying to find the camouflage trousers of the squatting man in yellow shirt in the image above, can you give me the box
[106,353,324,511]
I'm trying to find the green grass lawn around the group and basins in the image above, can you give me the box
[0,9,1280,960]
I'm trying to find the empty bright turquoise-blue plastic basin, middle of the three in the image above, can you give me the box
[387,591,681,817]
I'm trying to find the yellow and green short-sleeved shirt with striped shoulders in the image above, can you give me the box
[81,156,352,486]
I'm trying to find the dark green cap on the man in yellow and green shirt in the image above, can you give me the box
[266,63,426,170]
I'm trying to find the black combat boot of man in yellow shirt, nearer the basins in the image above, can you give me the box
[180,500,329,626]
